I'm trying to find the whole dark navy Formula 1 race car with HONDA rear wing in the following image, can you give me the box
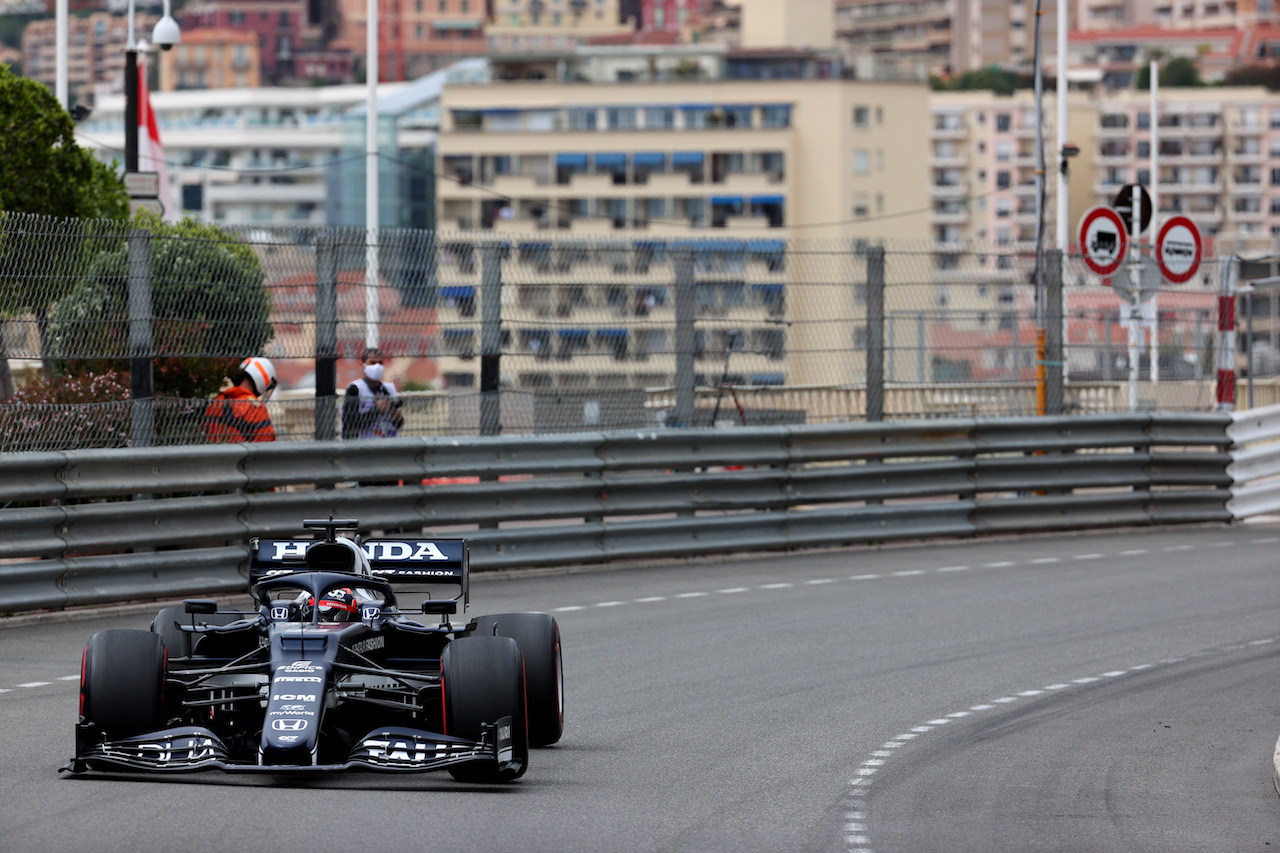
[61,519,564,783]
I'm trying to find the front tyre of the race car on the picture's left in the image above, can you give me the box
[81,630,166,740]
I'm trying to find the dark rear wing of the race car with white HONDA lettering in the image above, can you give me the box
[248,539,471,608]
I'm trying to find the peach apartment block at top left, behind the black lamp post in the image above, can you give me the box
[22,12,159,101]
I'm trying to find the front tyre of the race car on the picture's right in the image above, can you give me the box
[440,637,529,784]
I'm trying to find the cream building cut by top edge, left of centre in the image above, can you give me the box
[485,0,634,51]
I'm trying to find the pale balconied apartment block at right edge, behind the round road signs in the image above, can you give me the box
[1093,88,1280,254]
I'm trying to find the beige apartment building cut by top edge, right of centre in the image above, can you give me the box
[836,0,1057,78]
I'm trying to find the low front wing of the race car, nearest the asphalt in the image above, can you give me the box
[59,717,512,774]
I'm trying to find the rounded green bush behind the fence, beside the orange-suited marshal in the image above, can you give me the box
[50,216,273,397]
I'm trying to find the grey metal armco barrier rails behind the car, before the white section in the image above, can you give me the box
[0,414,1231,612]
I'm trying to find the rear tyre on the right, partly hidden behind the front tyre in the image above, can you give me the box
[472,613,564,747]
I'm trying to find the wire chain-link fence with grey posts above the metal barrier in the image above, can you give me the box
[0,214,1239,450]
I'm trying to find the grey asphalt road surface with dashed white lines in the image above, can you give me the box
[0,525,1280,853]
